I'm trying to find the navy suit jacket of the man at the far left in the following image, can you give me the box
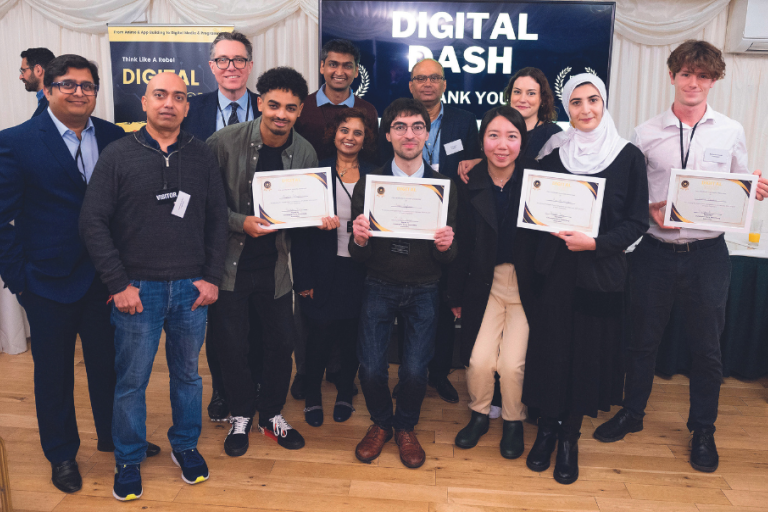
[0,111,125,304]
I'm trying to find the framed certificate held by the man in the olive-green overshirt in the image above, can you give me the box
[253,167,334,229]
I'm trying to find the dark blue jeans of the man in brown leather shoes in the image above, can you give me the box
[357,277,439,430]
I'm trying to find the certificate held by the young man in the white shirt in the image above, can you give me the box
[664,169,758,233]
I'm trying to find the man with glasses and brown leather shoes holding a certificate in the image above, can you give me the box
[349,99,457,468]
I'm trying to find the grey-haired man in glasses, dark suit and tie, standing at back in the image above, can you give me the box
[181,32,261,421]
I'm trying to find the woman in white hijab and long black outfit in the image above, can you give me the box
[520,74,648,484]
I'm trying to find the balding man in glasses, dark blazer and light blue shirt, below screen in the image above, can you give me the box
[378,59,480,403]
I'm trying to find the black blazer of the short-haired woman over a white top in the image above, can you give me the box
[291,158,376,307]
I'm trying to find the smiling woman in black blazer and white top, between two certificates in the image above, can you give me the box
[291,108,374,427]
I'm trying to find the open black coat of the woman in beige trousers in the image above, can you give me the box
[447,157,538,365]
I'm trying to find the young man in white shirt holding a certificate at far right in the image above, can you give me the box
[594,40,768,472]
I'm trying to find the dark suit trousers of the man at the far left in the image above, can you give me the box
[20,278,115,464]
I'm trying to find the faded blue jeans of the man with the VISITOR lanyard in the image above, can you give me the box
[112,279,208,464]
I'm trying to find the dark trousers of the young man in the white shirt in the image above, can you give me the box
[624,235,731,432]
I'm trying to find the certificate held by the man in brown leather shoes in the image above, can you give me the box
[363,174,451,240]
